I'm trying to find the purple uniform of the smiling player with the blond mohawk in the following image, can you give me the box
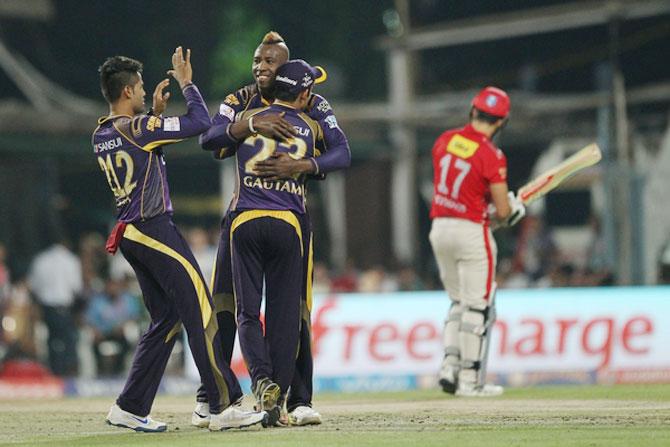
[197,84,351,411]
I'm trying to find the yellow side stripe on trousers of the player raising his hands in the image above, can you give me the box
[123,224,230,408]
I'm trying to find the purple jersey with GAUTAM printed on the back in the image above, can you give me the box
[230,103,326,214]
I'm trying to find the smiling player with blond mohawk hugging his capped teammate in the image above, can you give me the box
[192,31,351,426]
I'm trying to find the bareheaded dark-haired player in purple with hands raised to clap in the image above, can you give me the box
[92,47,267,432]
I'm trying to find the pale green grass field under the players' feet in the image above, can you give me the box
[0,385,670,447]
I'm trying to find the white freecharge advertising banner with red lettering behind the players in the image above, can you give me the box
[190,287,670,390]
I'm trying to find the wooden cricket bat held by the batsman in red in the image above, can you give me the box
[516,143,602,205]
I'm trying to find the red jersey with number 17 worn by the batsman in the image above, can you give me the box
[430,124,507,223]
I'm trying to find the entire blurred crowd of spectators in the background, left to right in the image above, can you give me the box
[0,216,663,377]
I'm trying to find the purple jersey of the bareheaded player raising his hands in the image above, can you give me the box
[92,84,211,222]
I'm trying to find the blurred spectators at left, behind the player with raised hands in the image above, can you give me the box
[0,227,223,377]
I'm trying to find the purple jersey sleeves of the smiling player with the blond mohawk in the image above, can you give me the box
[200,84,351,174]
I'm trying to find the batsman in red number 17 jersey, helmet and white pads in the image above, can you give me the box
[430,87,525,396]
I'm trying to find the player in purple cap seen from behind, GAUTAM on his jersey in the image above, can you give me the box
[217,60,350,425]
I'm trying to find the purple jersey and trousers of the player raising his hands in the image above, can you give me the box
[92,84,242,416]
